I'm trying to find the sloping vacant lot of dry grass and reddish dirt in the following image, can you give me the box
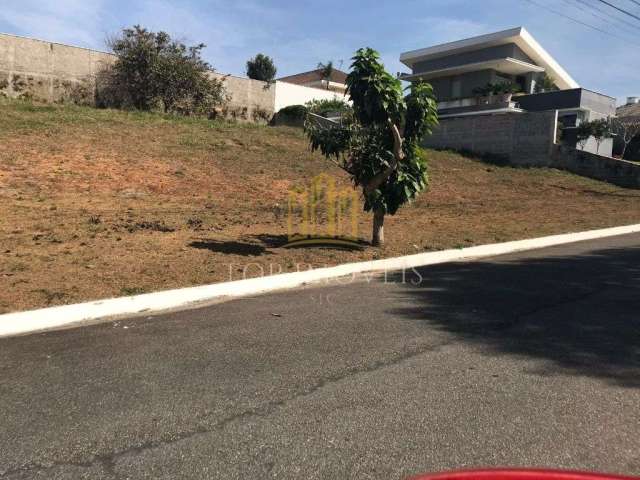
[0,102,640,312]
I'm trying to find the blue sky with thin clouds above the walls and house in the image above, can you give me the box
[0,0,640,99]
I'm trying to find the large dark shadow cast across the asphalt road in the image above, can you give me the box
[387,247,640,388]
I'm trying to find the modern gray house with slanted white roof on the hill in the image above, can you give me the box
[400,27,616,155]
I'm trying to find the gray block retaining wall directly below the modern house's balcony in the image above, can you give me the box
[423,111,556,166]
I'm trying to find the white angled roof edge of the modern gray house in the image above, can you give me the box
[400,27,580,89]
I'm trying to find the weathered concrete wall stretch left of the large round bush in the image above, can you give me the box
[0,34,115,103]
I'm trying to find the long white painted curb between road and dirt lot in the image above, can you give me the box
[0,224,640,337]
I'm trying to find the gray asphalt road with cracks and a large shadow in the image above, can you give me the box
[0,235,640,480]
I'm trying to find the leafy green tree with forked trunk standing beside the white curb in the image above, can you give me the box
[305,48,438,245]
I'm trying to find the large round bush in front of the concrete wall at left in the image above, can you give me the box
[98,25,226,115]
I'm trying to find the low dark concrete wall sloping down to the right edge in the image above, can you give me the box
[552,145,640,189]
